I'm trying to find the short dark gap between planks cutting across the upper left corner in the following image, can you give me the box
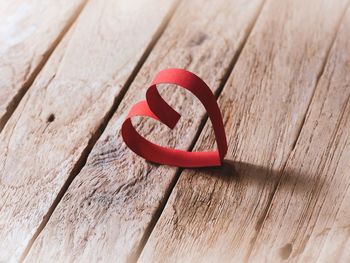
[0,0,88,133]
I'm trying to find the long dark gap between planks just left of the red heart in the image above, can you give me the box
[17,0,181,263]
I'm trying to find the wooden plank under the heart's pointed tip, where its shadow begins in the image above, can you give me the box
[139,0,346,262]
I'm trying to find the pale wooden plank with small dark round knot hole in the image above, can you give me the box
[0,0,178,262]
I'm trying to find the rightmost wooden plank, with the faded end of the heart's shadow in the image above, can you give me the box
[249,6,350,262]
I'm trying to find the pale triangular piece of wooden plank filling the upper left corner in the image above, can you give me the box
[0,0,86,131]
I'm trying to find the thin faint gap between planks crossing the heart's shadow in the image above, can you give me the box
[244,1,350,262]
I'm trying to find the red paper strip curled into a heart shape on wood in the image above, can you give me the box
[122,68,227,167]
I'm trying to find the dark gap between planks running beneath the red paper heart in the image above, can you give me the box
[135,0,268,262]
